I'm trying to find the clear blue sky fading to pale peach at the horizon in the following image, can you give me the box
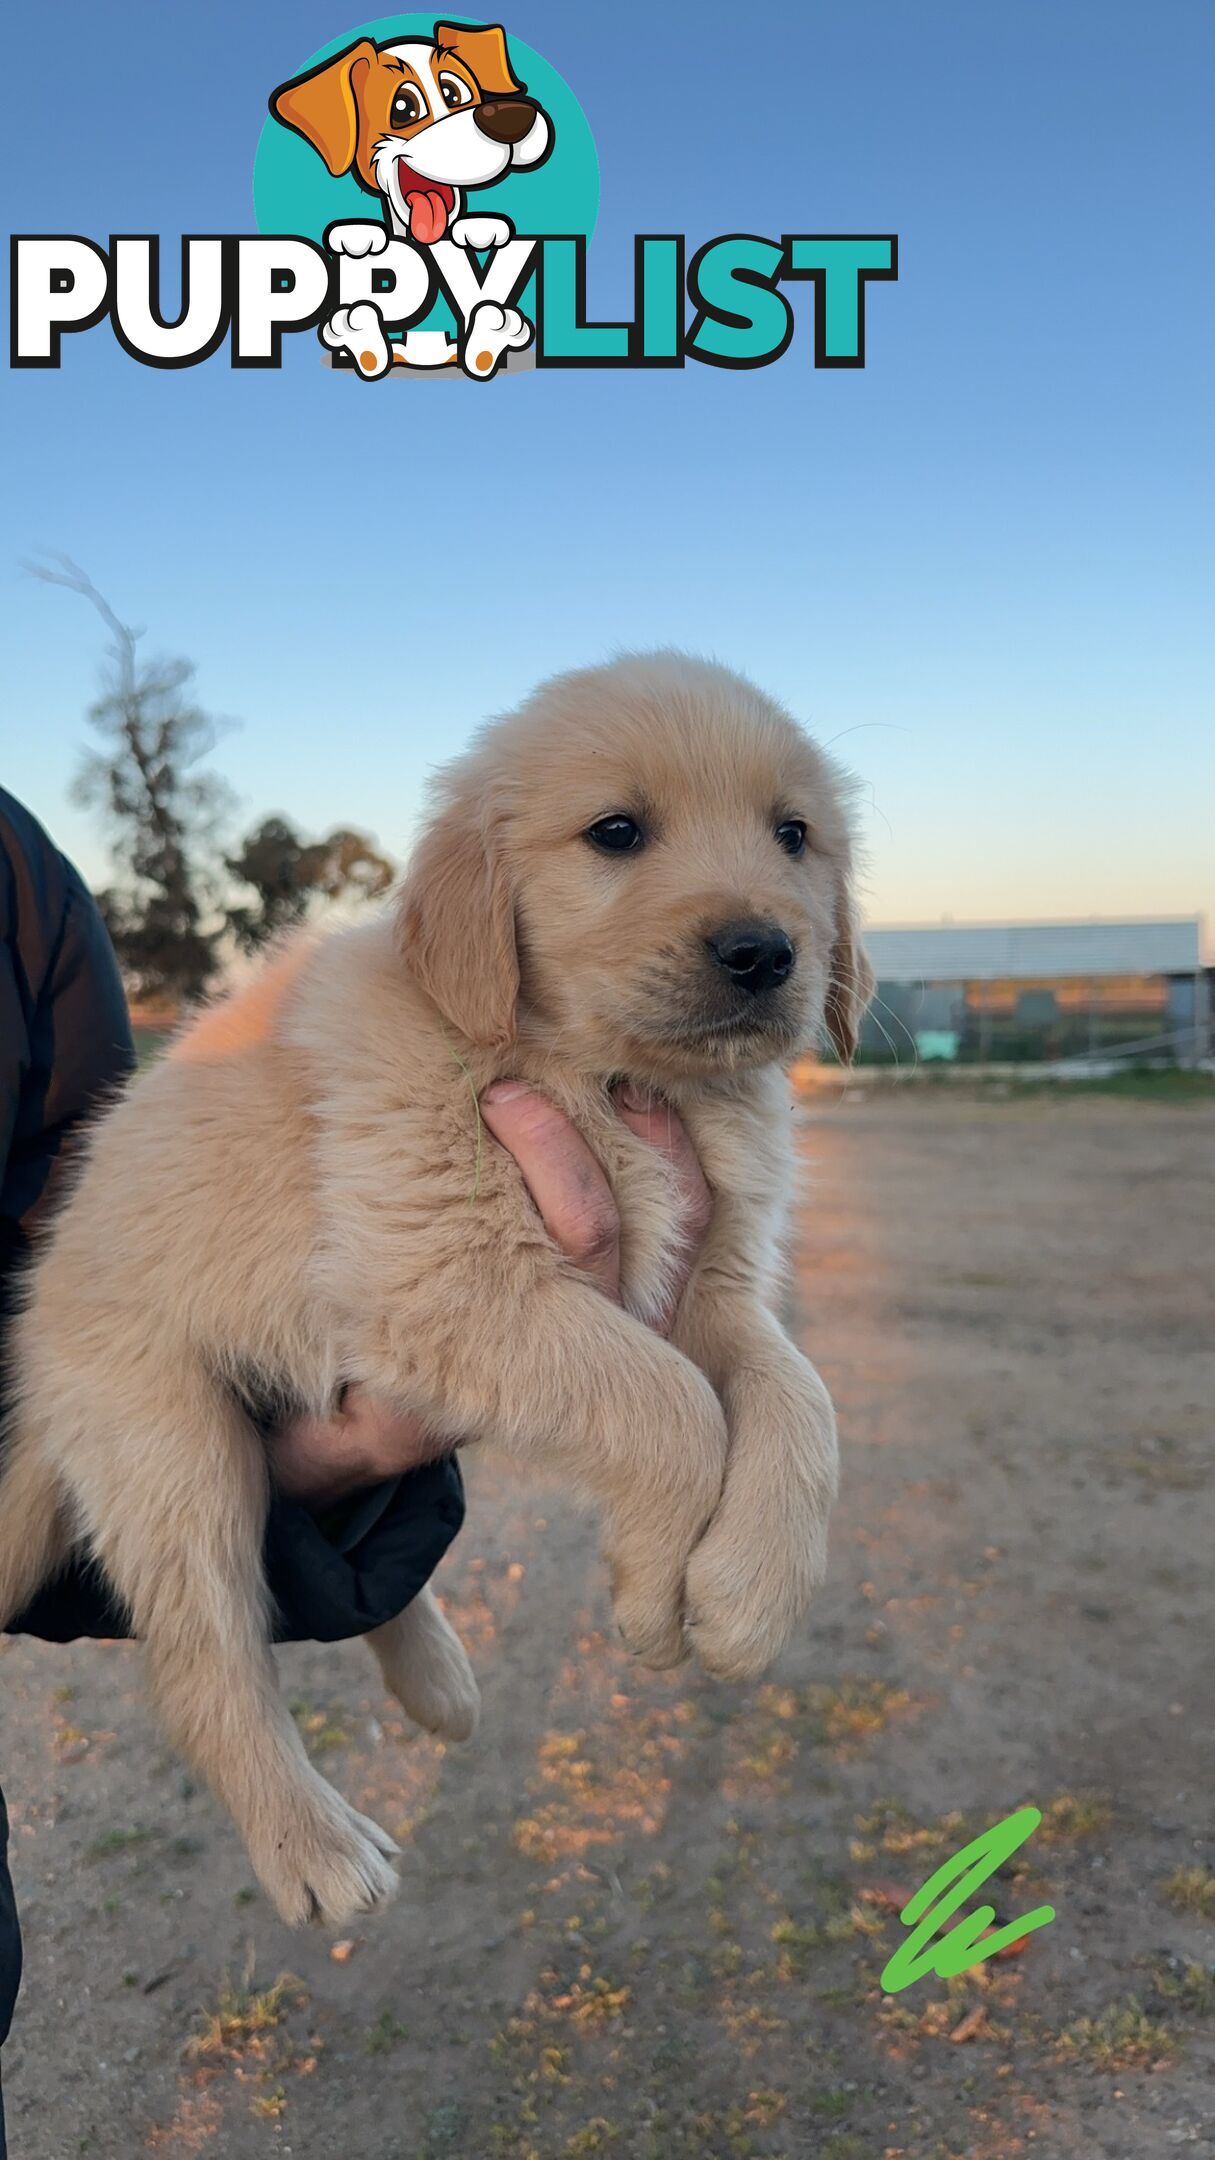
[0,0,1215,941]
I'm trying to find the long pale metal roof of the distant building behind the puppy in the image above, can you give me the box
[865,916,1200,983]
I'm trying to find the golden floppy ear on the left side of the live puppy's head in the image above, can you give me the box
[398,801,519,1050]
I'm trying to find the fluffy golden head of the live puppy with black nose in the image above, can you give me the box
[400,652,871,1082]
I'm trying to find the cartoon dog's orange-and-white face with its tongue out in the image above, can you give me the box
[270,22,553,246]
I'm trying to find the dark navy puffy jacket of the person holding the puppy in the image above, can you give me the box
[0,788,465,1642]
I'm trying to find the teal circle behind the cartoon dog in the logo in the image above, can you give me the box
[253,15,599,333]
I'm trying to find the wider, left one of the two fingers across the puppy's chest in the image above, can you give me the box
[480,1080,620,1300]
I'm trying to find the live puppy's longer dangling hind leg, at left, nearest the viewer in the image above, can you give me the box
[74,1365,396,1927]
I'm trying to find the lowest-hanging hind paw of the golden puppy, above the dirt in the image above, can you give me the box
[249,1778,400,1927]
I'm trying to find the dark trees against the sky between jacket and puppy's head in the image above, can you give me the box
[32,557,393,1004]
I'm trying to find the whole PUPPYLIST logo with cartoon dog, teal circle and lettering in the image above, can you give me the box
[11,15,897,382]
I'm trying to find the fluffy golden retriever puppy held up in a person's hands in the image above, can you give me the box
[0,652,869,1925]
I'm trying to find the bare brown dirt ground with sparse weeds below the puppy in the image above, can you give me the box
[0,1089,1215,2160]
